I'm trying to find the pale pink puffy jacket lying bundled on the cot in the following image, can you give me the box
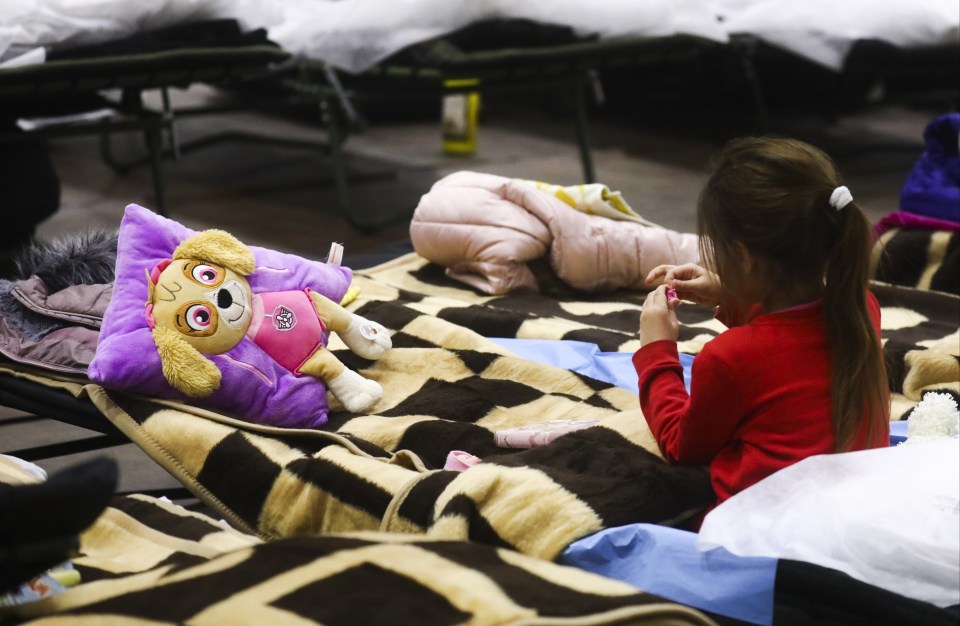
[410,172,699,295]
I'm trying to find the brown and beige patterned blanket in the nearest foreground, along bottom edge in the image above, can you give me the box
[0,460,714,626]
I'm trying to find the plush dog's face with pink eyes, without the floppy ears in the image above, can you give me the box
[147,259,252,354]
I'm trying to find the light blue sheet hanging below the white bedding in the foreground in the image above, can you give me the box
[558,524,777,626]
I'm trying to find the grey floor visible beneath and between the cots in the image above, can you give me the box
[0,78,940,508]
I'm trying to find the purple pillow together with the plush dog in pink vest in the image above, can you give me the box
[88,204,390,428]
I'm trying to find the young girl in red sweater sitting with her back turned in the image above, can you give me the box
[633,138,889,520]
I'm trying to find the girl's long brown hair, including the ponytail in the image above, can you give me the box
[697,137,888,451]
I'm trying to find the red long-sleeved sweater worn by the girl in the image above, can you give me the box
[633,293,890,520]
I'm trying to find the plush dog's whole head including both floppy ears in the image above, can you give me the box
[146,230,255,398]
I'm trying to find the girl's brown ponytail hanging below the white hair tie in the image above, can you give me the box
[823,203,889,452]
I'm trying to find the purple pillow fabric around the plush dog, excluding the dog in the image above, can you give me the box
[87,204,352,428]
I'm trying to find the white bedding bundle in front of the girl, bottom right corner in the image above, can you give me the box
[697,437,960,607]
